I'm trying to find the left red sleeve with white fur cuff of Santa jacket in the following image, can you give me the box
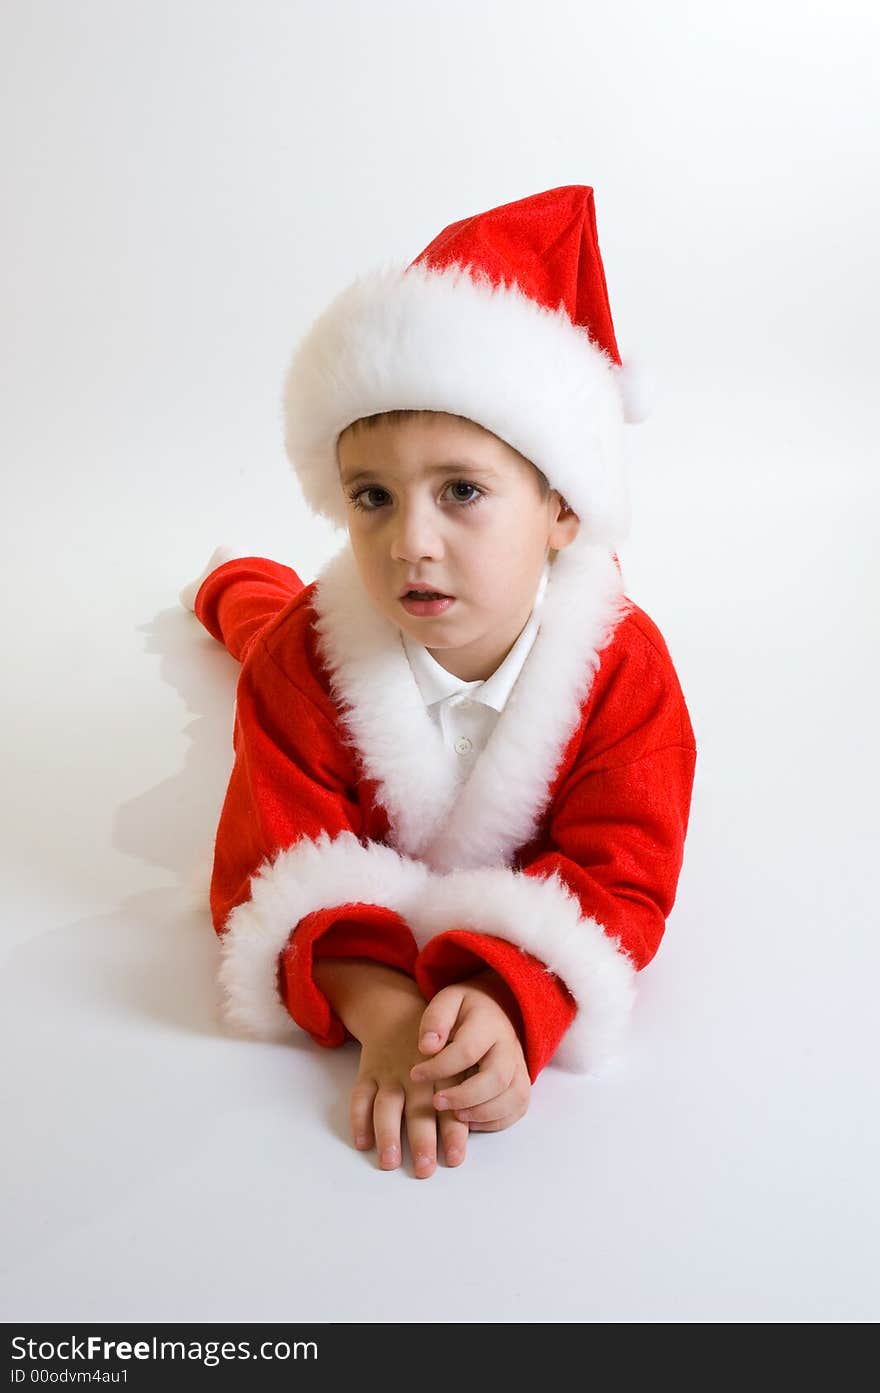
[210,639,423,1045]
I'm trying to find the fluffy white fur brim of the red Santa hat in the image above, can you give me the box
[283,263,629,547]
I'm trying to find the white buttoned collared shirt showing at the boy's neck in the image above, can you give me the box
[401,561,550,777]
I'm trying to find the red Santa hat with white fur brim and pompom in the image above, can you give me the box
[284,184,646,546]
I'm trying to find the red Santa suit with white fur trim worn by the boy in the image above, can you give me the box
[195,543,696,1080]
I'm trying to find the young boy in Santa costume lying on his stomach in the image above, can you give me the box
[181,185,696,1177]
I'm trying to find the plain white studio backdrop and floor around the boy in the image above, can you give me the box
[0,0,880,1320]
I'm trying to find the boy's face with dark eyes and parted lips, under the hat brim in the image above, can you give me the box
[337,412,579,681]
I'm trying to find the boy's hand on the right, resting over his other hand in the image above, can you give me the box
[409,970,532,1131]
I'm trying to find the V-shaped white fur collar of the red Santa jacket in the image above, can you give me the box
[313,539,628,871]
